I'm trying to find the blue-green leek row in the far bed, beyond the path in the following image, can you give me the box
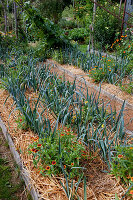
[52,46,133,84]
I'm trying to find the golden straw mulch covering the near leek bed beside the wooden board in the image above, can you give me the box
[0,89,130,200]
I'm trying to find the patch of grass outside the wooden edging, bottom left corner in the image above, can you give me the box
[0,135,32,200]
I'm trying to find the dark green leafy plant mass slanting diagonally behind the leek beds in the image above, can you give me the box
[24,2,70,48]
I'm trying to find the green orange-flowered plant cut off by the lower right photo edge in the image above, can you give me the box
[111,146,133,184]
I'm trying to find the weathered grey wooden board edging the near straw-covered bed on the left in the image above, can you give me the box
[0,117,39,200]
